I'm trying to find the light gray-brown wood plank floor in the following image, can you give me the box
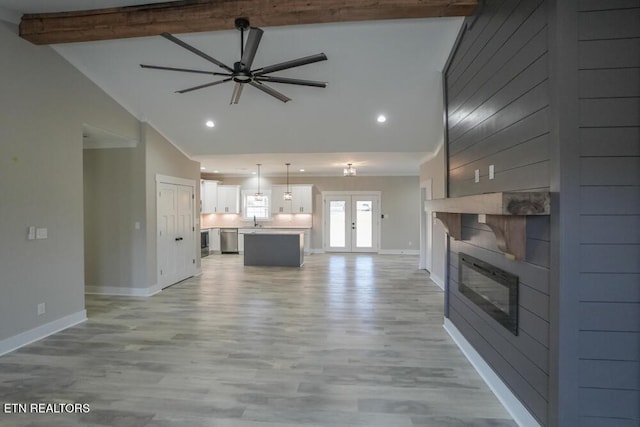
[0,254,515,427]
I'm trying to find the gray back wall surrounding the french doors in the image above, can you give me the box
[216,176,421,251]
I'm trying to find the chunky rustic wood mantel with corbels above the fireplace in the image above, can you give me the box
[424,192,551,260]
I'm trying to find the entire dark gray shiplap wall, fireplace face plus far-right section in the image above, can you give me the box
[446,0,640,427]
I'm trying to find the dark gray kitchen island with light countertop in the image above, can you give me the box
[244,230,304,267]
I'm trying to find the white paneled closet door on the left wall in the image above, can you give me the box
[157,182,195,288]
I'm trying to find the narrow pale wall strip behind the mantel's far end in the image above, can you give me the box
[420,144,447,288]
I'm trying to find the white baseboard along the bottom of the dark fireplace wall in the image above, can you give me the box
[442,318,540,427]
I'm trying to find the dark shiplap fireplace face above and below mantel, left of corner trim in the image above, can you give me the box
[445,0,550,425]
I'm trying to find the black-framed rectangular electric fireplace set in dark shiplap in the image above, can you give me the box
[458,253,518,335]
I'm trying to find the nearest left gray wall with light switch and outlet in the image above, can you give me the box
[0,21,138,342]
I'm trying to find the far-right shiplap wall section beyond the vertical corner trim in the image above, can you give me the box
[577,0,640,427]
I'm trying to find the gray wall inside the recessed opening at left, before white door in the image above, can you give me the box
[83,143,148,292]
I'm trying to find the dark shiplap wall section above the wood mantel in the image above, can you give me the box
[446,0,549,197]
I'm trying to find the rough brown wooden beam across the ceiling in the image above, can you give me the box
[20,0,478,44]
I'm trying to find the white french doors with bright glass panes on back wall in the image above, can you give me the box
[324,193,380,252]
